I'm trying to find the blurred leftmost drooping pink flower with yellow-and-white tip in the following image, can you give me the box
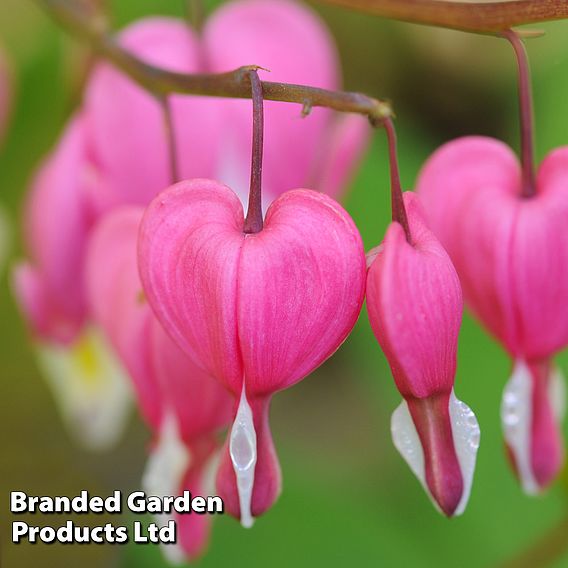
[13,118,130,449]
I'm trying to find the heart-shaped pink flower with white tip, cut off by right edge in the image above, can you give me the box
[418,137,568,493]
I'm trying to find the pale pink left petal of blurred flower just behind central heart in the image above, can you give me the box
[85,207,163,431]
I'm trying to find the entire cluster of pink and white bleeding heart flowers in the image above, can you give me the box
[10,0,568,561]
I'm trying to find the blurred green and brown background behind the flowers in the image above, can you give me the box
[0,0,568,568]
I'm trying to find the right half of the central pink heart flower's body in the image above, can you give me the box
[238,190,365,395]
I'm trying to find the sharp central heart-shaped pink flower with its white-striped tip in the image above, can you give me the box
[139,180,365,526]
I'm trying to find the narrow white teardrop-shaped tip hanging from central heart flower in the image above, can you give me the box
[229,382,257,528]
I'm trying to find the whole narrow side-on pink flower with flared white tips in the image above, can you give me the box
[367,193,479,516]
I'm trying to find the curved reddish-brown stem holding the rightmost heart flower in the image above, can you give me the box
[502,30,536,197]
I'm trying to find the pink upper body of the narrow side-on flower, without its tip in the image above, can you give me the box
[367,193,462,398]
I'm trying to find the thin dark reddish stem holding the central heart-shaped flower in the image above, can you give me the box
[244,70,264,233]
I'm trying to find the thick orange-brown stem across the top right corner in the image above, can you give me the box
[319,0,568,34]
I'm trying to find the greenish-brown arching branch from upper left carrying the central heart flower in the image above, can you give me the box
[36,0,392,124]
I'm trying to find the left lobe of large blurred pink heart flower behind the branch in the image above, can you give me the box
[85,18,219,209]
